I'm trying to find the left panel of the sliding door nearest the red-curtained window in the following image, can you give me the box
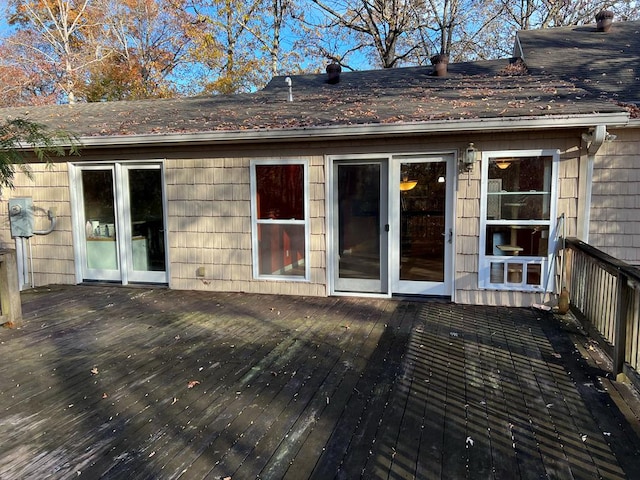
[333,161,388,293]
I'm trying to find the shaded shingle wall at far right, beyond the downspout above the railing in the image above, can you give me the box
[588,128,640,265]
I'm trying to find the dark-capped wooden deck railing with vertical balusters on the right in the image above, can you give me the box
[563,238,640,388]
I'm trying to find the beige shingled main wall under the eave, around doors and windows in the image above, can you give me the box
[0,130,584,306]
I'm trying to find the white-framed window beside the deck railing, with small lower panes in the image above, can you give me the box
[478,150,559,291]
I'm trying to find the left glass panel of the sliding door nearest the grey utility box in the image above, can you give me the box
[81,168,121,281]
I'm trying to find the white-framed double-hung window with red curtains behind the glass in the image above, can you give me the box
[251,160,309,280]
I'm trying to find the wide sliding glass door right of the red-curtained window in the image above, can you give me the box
[328,155,455,296]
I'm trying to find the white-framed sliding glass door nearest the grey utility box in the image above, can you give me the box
[77,164,167,284]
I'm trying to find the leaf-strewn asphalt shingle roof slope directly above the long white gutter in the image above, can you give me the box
[0,59,621,137]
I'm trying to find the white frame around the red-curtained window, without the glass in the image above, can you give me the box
[249,159,311,282]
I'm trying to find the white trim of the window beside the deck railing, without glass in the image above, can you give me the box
[478,149,560,292]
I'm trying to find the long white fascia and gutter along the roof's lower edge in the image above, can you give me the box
[78,112,629,147]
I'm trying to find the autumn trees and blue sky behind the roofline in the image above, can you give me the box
[0,0,638,106]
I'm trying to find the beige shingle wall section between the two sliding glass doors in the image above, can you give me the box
[165,156,327,296]
